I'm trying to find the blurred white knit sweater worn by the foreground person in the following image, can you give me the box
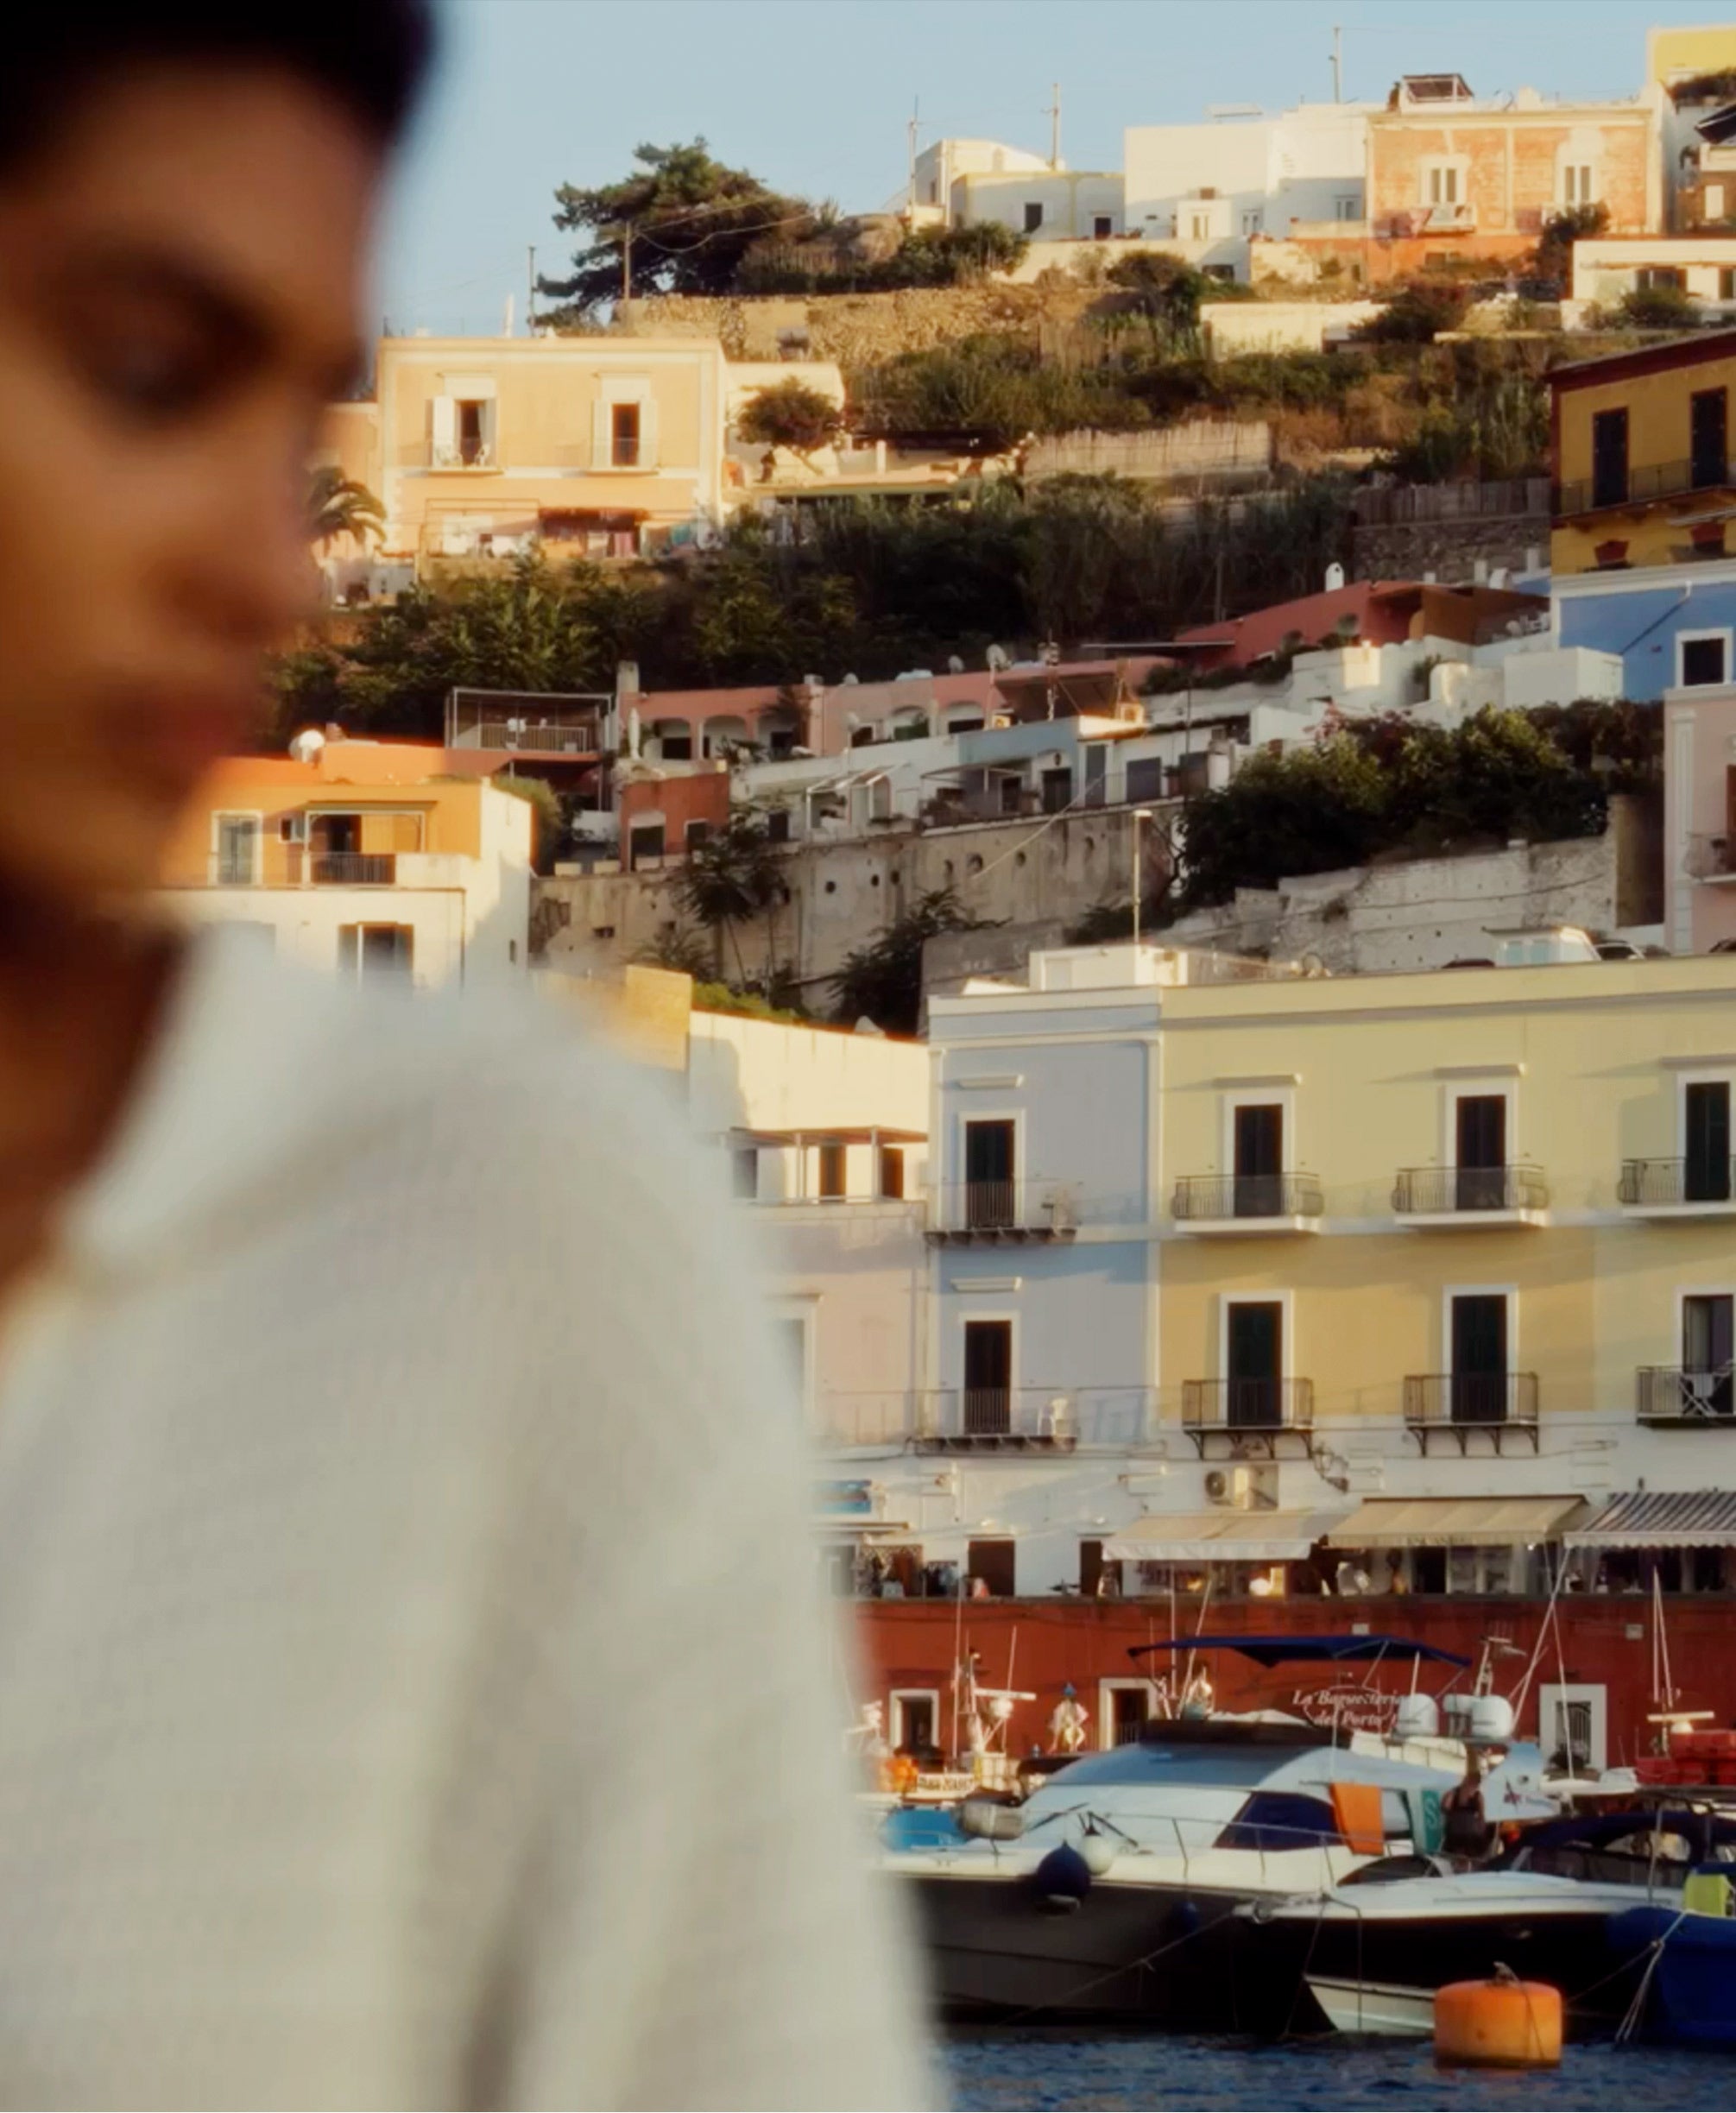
[0,932,928,2107]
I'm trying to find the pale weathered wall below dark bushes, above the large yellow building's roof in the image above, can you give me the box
[1163,829,1656,975]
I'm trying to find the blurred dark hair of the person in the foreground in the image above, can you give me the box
[0,0,433,171]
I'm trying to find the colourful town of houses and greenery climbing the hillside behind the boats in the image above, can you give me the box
[142,0,1736,2071]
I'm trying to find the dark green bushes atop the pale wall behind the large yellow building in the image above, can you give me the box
[1177,703,1657,909]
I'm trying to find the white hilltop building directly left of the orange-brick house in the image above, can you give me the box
[1123,104,1379,279]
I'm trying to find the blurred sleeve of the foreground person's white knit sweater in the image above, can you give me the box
[480,1056,932,2107]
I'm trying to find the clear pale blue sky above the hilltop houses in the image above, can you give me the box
[376,0,1732,331]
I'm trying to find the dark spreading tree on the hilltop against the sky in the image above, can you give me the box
[537,140,814,324]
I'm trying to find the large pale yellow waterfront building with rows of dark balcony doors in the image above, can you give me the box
[1157,955,1736,1589]
